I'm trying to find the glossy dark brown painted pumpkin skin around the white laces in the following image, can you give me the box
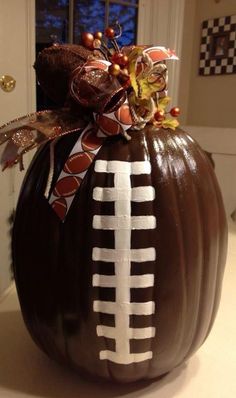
[13,128,227,382]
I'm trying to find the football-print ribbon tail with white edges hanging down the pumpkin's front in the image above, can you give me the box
[49,101,132,221]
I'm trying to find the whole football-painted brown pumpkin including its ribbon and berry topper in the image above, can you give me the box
[2,23,227,382]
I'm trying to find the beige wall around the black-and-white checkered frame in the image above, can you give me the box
[179,0,236,128]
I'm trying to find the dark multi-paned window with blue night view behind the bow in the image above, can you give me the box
[36,0,138,110]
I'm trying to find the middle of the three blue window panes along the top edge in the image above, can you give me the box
[74,0,105,43]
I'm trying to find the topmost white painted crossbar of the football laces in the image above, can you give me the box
[94,160,151,175]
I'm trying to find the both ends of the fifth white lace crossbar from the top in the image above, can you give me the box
[93,274,154,289]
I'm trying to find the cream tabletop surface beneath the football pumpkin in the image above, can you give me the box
[0,223,236,398]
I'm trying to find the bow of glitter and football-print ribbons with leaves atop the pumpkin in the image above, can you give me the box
[0,24,179,220]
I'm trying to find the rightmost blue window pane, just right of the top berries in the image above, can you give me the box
[109,3,138,46]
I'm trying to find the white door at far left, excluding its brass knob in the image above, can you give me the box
[0,0,35,295]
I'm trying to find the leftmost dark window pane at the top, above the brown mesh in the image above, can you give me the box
[36,0,69,43]
